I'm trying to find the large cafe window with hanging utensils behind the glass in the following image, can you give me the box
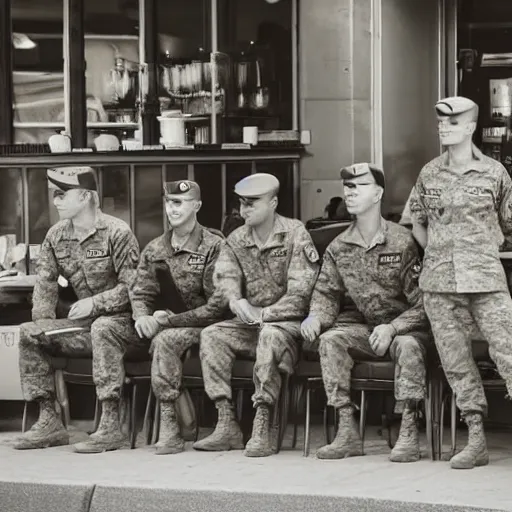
[6,0,298,150]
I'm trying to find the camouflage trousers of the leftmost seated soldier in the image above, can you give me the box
[19,315,149,401]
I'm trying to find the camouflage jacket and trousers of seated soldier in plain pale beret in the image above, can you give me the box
[201,215,318,406]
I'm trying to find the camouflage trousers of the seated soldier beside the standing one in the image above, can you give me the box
[318,322,429,409]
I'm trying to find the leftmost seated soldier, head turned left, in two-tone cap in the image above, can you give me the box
[15,167,143,452]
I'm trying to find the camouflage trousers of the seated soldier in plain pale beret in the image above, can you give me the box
[200,320,300,406]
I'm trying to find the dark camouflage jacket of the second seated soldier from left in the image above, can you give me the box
[130,223,226,327]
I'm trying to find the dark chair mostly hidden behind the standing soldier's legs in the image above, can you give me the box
[438,340,507,457]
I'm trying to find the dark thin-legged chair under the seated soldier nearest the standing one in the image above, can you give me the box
[292,359,437,460]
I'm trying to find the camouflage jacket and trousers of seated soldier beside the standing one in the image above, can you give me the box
[310,219,429,409]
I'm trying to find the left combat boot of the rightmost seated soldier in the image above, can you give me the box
[316,407,363,459]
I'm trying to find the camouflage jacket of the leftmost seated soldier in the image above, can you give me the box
[32,212,139,321]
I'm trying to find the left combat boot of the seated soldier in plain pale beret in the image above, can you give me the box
[192,399,244,452]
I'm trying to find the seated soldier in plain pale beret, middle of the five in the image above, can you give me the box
[194,173,319,457]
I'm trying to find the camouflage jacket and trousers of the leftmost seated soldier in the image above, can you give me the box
[19,212,143,401]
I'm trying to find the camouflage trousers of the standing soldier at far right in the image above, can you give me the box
[423,292,512,415]
